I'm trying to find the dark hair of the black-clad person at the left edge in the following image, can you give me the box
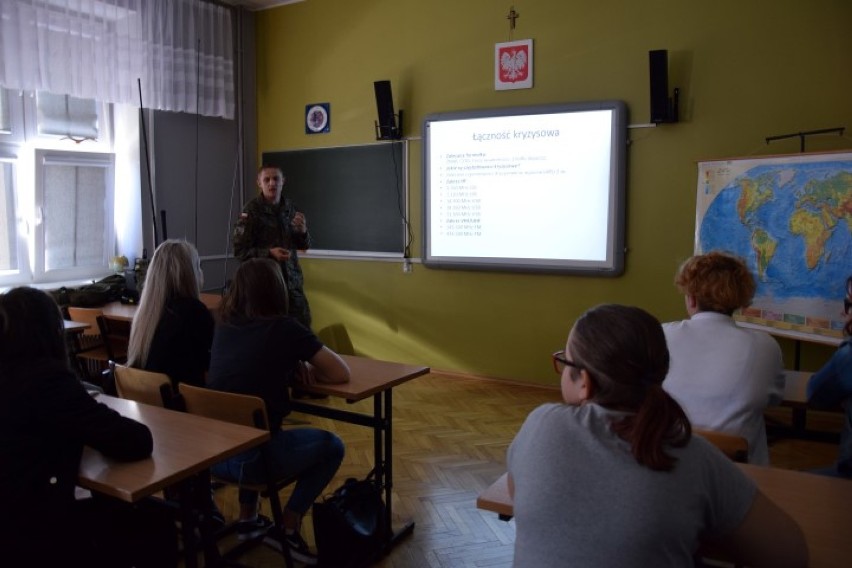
[0,287,68,374]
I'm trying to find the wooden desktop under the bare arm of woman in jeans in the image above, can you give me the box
[302,355,430,401]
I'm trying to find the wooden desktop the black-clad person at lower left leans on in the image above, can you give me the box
[78,395,269,502]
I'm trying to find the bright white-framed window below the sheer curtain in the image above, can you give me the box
[0,89,115,286]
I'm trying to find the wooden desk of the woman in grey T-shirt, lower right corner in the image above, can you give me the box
[476,464,852,568]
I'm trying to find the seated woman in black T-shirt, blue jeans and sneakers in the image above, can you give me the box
[207,258,349,564]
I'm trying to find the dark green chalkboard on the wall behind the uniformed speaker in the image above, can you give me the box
[263,142,406,255]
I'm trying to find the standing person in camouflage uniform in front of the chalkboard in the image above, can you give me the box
[234,165,311,329]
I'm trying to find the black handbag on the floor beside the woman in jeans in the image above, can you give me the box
[312,471,387,568]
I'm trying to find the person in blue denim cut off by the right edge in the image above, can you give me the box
[808,276,852,477]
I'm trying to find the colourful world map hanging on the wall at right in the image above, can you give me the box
[695,153,852,338]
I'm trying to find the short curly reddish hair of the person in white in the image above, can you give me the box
[675,251,757,315]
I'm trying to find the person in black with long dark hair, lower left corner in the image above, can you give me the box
[0,288,177,568]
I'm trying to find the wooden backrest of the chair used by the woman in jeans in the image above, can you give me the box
[178,383,269,430]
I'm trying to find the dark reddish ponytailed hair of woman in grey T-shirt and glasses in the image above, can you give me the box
[568,304,692,471]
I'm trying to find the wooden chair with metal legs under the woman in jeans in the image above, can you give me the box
[178,383,295,568]
